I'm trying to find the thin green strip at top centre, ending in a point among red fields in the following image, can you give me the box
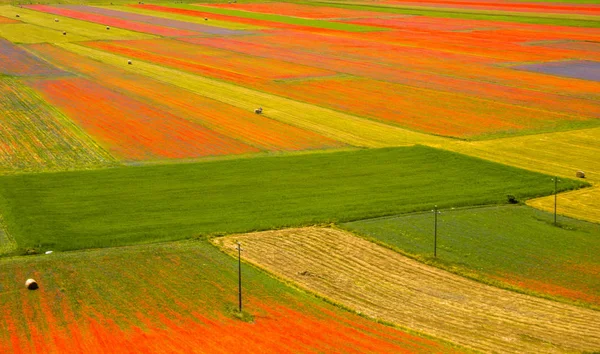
[166,4,387,32]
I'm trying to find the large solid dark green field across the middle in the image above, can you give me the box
[0,146,584,250]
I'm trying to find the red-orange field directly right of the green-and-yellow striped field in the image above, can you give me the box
[34,79,259,160]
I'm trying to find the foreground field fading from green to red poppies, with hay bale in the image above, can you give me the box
[0,241,457,353]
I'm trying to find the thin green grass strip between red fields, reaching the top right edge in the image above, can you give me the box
[312,1,600,28]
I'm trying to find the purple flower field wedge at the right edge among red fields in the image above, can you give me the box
[515,60,600,81]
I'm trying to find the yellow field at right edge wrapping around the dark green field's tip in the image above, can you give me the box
[438,128,600,222]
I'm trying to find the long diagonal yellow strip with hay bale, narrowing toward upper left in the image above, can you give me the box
[60,43,446,147]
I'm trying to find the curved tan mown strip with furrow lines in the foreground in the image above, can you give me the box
[213,227,600,353]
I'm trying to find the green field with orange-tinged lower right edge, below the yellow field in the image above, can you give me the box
[343,206,600,307]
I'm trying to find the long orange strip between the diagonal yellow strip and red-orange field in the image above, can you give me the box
[29,44,343,150]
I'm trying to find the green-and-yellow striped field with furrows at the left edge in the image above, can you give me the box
[0,78,114,171]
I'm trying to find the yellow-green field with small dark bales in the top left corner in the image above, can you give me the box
[0,6,156,43]
